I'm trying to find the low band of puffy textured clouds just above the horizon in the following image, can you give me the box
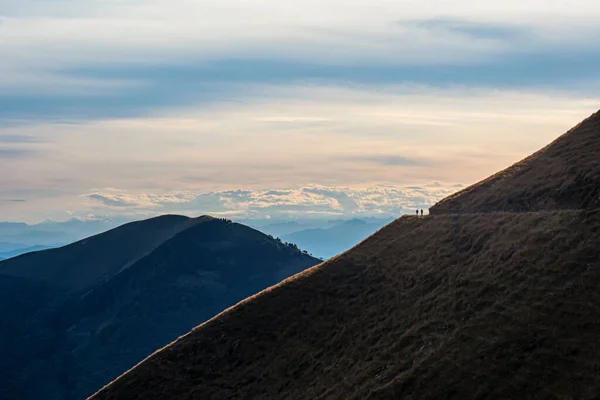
[86,183,464,219]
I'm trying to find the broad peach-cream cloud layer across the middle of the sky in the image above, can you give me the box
[0,84,600,207]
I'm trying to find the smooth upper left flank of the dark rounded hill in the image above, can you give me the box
[0,215,199,290]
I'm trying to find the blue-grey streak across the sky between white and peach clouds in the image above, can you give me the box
[0,48,600,122]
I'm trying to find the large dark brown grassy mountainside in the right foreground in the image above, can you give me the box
[92,110,600,400]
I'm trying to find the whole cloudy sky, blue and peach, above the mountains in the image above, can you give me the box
[0,0,600,223]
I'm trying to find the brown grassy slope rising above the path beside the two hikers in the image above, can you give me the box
[430,111,600,214]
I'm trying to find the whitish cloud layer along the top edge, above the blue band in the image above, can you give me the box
[0,0,600,88]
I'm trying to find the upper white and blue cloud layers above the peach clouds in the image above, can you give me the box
[0,0,600,120]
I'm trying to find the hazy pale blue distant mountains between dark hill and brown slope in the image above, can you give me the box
[281,218,393,259]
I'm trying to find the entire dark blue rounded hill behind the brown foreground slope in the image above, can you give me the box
[0,215,319,399]
